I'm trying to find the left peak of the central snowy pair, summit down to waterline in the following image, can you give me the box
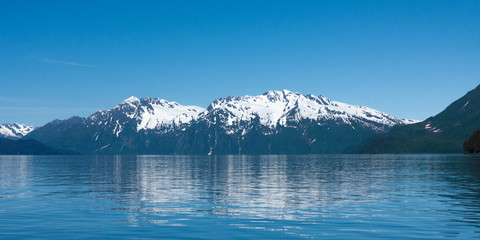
[27,97,205,153]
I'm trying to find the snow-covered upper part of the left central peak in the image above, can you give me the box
[87,97,205,137]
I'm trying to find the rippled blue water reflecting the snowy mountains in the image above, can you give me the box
[0,155,480,239]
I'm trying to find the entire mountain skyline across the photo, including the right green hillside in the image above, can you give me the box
[4,85,480,155]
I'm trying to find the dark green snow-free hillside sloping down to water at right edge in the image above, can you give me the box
[348,85,480,153]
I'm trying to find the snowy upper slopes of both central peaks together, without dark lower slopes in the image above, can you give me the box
[79,90,412,139]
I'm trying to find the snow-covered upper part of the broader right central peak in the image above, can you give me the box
[205,90,415,133]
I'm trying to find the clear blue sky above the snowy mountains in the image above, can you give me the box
[0,0,480,126]
